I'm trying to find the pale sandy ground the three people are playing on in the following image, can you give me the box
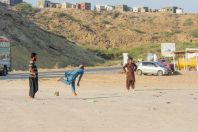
[0,73,198,132]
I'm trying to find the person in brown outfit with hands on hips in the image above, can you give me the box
[123,58,137,91]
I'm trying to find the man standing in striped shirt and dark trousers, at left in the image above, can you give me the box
[29,53,38,99]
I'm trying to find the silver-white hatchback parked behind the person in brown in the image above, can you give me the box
[137,62,171,76]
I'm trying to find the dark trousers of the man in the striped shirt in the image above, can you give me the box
[29,77,38,98]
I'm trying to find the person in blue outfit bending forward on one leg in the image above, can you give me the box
[63,65,84,96]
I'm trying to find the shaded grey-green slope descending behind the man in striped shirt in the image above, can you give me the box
[0,4,103,70]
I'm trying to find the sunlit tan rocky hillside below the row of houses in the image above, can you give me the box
[30,9,198,48]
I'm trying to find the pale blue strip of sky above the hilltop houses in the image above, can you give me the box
[24,0,198,13]
